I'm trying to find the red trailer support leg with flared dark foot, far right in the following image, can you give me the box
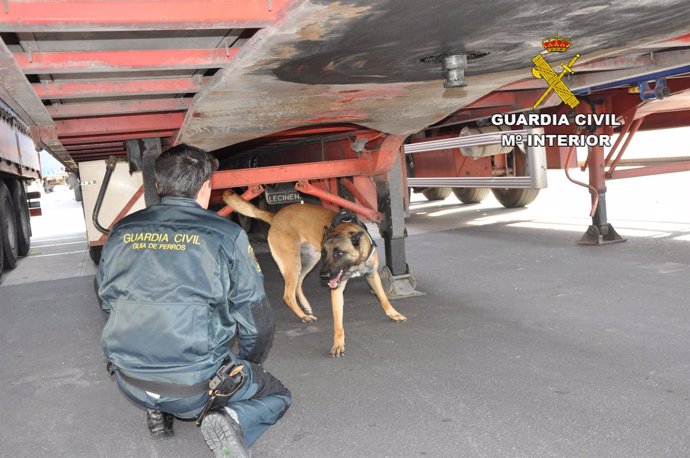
[577,141,625,245]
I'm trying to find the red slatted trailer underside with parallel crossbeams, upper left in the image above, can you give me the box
[0,8,264,165]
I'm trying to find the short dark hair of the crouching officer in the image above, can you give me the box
[153,145,214,199]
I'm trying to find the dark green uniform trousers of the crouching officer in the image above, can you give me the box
[117,360,292,446]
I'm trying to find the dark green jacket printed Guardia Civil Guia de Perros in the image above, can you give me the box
[97,197,273,398]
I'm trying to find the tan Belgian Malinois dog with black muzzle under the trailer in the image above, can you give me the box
[223,190,407,358]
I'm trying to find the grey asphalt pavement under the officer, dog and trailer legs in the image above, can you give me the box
[0,172,690,457]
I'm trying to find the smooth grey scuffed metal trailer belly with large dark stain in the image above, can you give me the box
[177,0,690,150]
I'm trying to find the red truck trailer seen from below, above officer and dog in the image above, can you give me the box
[0,0,690,295]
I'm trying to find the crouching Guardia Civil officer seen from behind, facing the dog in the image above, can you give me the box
[96,145,291,456]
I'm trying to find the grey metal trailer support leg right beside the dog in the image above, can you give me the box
[377,151,424,299]
